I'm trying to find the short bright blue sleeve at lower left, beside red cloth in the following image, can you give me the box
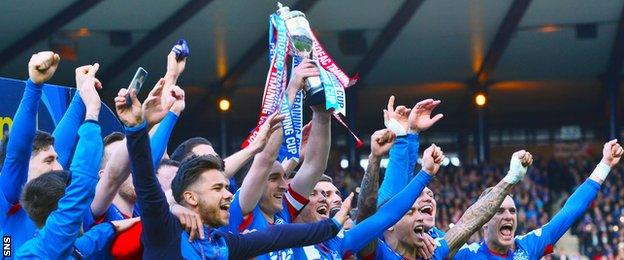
[74,222,115,259]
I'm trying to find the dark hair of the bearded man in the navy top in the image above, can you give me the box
[171,155,223,204]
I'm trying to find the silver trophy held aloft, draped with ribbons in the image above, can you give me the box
[277,2,325,105]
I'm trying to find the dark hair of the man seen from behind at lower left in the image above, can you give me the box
[20,171,70,228]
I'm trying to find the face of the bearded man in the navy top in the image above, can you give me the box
[193,169,232,227]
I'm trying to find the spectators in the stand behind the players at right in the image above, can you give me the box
[331,156,624,259]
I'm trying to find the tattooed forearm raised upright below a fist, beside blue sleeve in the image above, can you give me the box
[356,154,381,256]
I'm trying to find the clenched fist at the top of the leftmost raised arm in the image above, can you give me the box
[28,51,61,85]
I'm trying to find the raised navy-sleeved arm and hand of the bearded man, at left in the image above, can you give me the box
[115,86,178,246]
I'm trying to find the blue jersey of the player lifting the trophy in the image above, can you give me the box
[221,186,309,259]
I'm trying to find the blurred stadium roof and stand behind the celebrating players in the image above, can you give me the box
[0,0,624,257]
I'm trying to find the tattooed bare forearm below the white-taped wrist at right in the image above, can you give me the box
[444,181,513,257]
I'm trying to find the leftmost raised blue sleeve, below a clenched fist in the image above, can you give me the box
[0,79,43,205]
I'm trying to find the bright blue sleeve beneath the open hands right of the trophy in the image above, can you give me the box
[377,136,411,207]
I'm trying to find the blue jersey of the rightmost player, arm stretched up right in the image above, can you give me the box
[455,179,600,259]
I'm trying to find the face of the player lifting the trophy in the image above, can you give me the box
[260,162,288,214]
